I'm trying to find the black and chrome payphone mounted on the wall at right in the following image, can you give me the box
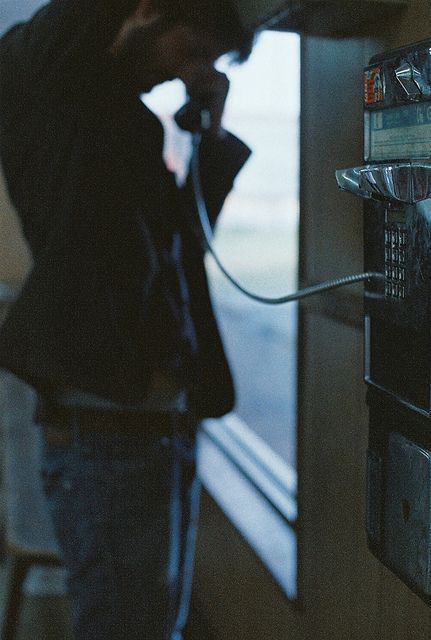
[337,40,431,604]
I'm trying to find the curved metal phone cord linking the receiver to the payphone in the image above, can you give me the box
[190,133,384,305]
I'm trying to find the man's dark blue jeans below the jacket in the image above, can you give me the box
[42,420,199,640]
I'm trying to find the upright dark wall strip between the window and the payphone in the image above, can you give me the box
[299,22,431,640]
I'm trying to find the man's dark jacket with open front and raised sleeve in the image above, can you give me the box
[0,0,249,416]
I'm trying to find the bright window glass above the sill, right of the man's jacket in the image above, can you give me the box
[208,31,299,466]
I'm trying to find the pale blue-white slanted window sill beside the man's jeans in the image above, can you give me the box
[199,414,297,600]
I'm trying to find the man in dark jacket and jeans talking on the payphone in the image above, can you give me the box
[0,0,252,640]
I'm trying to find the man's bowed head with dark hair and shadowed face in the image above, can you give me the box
[112,0,253,91]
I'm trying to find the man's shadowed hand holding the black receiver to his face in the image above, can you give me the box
[177,62,229,137]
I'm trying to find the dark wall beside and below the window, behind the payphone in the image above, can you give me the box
[193,0,431,640]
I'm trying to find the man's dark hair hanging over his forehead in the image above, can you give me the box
[153,0,254,62]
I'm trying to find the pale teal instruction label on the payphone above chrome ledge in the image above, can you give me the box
[366,102,431,160]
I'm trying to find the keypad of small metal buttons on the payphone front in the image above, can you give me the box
[385,224,407,300]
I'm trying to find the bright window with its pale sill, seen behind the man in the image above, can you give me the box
[145,32,300,600]
